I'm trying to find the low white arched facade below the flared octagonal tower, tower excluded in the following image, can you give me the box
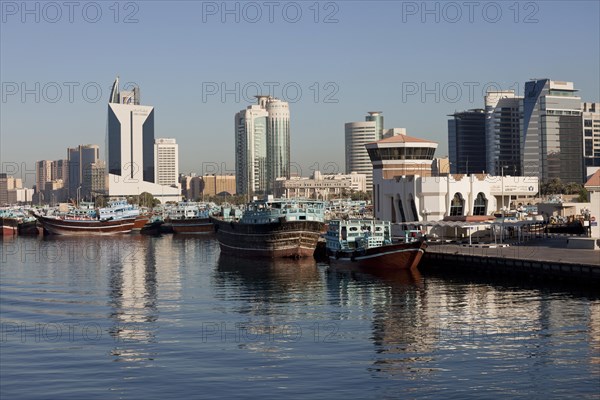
[373,170,538,222]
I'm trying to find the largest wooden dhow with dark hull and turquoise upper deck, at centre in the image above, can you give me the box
[211,198,324,258]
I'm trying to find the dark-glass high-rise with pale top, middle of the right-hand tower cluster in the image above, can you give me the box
[482,90,523,176]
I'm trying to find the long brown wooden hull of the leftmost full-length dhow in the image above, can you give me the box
[37,216,136,235]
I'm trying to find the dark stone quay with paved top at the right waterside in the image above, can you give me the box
[419,238,600,287]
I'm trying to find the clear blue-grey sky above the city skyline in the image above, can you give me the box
[0,0,600,186]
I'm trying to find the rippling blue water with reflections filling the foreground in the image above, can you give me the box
[0,235,600,399]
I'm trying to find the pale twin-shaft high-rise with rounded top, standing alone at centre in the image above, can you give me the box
[235,96,290,194]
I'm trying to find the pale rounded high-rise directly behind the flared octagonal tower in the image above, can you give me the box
[344,111,384,191]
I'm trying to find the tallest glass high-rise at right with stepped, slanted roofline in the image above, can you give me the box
[521,79,583,183]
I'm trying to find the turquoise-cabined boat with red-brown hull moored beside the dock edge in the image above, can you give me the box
[325,220,427,269]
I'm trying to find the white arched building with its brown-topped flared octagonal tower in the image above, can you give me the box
[366,135,538,223]
